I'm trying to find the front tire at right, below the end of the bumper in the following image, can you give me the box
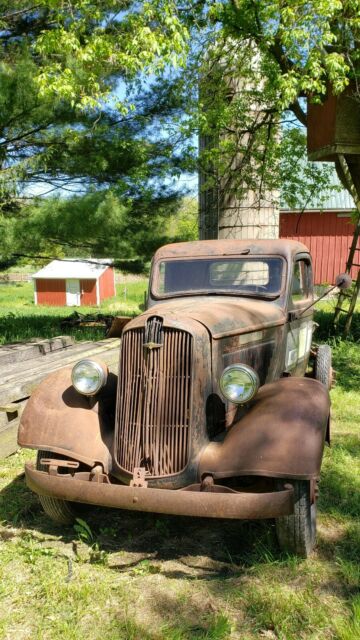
[276,480,316,558]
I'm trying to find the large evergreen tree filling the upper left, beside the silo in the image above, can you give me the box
[0,0,194,264]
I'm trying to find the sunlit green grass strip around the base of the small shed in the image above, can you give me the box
[0,277,147,344]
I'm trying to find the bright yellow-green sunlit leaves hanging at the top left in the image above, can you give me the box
[27,0,188,109]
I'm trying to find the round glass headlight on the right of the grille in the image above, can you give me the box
[220,364,260,404]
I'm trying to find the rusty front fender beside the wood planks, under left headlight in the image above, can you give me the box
[18,367,117,473]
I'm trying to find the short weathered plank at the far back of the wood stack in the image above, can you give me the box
[0,336,74,368]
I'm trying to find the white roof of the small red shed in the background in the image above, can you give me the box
[32,258,112,280]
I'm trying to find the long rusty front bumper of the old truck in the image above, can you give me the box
[25,463,294,520]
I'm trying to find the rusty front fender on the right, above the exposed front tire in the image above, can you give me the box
[199,378,330,479]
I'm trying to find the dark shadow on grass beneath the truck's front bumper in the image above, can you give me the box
[0,475,279,579]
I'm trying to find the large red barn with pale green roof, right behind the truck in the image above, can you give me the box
[280,178,360,284]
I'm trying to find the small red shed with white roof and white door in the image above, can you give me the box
[33,259,116,307]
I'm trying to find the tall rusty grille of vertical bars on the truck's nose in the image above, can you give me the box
[115,317,192,476]
